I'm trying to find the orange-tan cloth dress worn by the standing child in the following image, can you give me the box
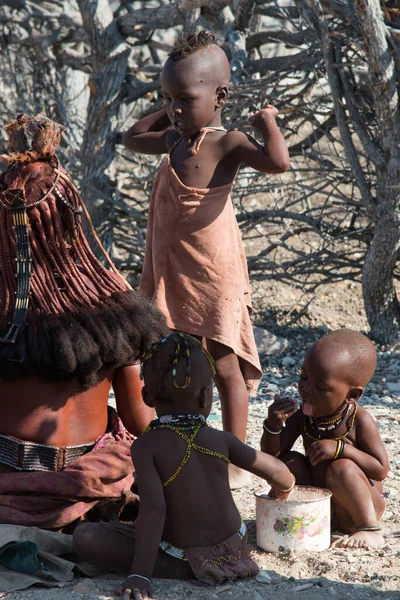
[139,139,262,393]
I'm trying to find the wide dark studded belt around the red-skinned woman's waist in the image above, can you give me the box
[0,434,94,471]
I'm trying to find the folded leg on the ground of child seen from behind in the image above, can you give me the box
[73,523,194,579]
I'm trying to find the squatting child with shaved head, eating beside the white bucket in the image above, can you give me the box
[261,329,389,548]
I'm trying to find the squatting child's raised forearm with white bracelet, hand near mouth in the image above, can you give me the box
[261,394,301,456]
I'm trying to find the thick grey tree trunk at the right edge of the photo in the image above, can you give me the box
[355,0,400,344]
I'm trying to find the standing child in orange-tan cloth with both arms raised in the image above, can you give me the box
[123,31,289,483]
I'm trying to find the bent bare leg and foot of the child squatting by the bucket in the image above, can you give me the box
[325,459,385,548]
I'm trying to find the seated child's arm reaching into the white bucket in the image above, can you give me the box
[224,431,294,499]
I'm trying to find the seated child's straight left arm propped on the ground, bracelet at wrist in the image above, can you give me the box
[123,436,167,598]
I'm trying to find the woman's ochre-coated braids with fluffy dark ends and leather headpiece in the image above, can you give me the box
[0,115,167,390]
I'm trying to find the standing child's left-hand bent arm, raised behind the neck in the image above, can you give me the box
[122,108,177,154]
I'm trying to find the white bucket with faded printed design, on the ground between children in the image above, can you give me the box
[255,486,332,552]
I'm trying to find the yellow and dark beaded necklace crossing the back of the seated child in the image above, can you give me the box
[143,414,230,487]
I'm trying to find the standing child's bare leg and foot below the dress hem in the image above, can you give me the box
[207,339,251,490]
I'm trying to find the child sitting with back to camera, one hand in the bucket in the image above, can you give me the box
[74,333,294,598]
